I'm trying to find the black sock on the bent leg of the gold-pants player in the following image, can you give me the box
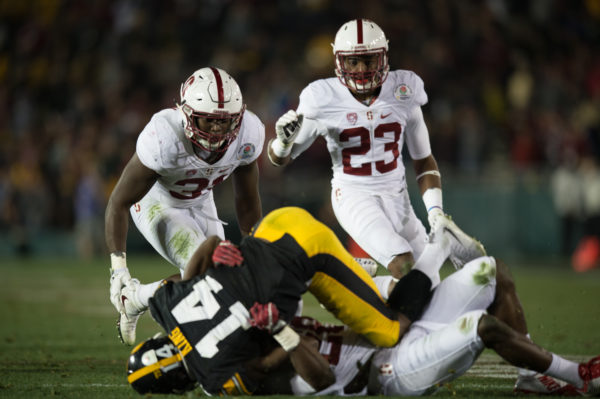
[388,269,431,321]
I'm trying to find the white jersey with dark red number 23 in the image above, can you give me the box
[292,70,431,191]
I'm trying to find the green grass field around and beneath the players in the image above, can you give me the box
[0,257,600,398]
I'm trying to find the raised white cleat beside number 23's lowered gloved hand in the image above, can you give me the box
[434,215,486,270]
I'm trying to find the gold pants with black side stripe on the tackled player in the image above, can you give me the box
[252,207,400,347]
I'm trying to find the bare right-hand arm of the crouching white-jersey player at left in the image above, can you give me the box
[232,161,262,236]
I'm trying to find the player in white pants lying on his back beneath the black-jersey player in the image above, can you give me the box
[246,257,600,396]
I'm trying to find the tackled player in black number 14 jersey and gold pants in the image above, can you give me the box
[128,207,481,394]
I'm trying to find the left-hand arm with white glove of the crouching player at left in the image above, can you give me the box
[104,154,158,312]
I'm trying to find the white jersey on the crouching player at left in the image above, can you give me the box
[136,108,265,208]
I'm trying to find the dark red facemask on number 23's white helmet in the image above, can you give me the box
[335,49,389,94]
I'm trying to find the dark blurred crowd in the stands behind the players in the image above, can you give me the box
[0,0,600,256]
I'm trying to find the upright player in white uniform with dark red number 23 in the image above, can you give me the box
[268,19,485,278]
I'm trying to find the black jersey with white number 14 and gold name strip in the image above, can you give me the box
[150,236,314,394]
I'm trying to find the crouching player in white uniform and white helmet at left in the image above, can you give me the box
[105,67,265,345]
